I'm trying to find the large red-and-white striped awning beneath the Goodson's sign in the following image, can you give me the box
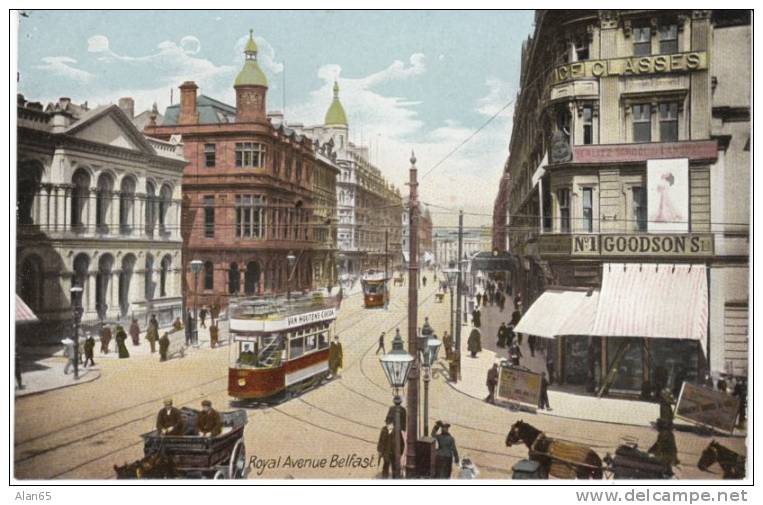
[591,263,708,348]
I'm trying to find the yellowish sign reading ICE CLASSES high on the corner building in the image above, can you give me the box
[554,51,707,83]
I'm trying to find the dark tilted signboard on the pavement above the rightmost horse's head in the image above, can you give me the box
[675,382,739,433]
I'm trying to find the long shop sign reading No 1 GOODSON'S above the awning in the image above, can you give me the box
[570,233,713,256]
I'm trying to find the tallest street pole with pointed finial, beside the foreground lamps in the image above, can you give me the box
[405,151,420,479]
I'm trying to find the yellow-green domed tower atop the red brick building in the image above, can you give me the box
[233,30,268,123]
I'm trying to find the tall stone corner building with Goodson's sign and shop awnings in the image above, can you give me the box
[496,10,751,394]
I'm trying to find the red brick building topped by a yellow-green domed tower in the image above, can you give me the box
[145,36,336,305]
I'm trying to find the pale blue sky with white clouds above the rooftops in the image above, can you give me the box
[18,11,533,226]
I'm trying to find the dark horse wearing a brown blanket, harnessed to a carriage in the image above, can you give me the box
[506,420,604,479]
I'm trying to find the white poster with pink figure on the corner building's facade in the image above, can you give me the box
[646,158,689,233]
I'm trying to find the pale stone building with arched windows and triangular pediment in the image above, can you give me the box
[16,95,186,339]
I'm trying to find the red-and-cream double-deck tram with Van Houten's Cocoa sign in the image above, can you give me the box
[228,292,341,401]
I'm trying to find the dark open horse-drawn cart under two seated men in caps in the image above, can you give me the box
[114,407,247,479]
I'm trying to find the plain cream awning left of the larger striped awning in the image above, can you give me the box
[514,289,598,338]
